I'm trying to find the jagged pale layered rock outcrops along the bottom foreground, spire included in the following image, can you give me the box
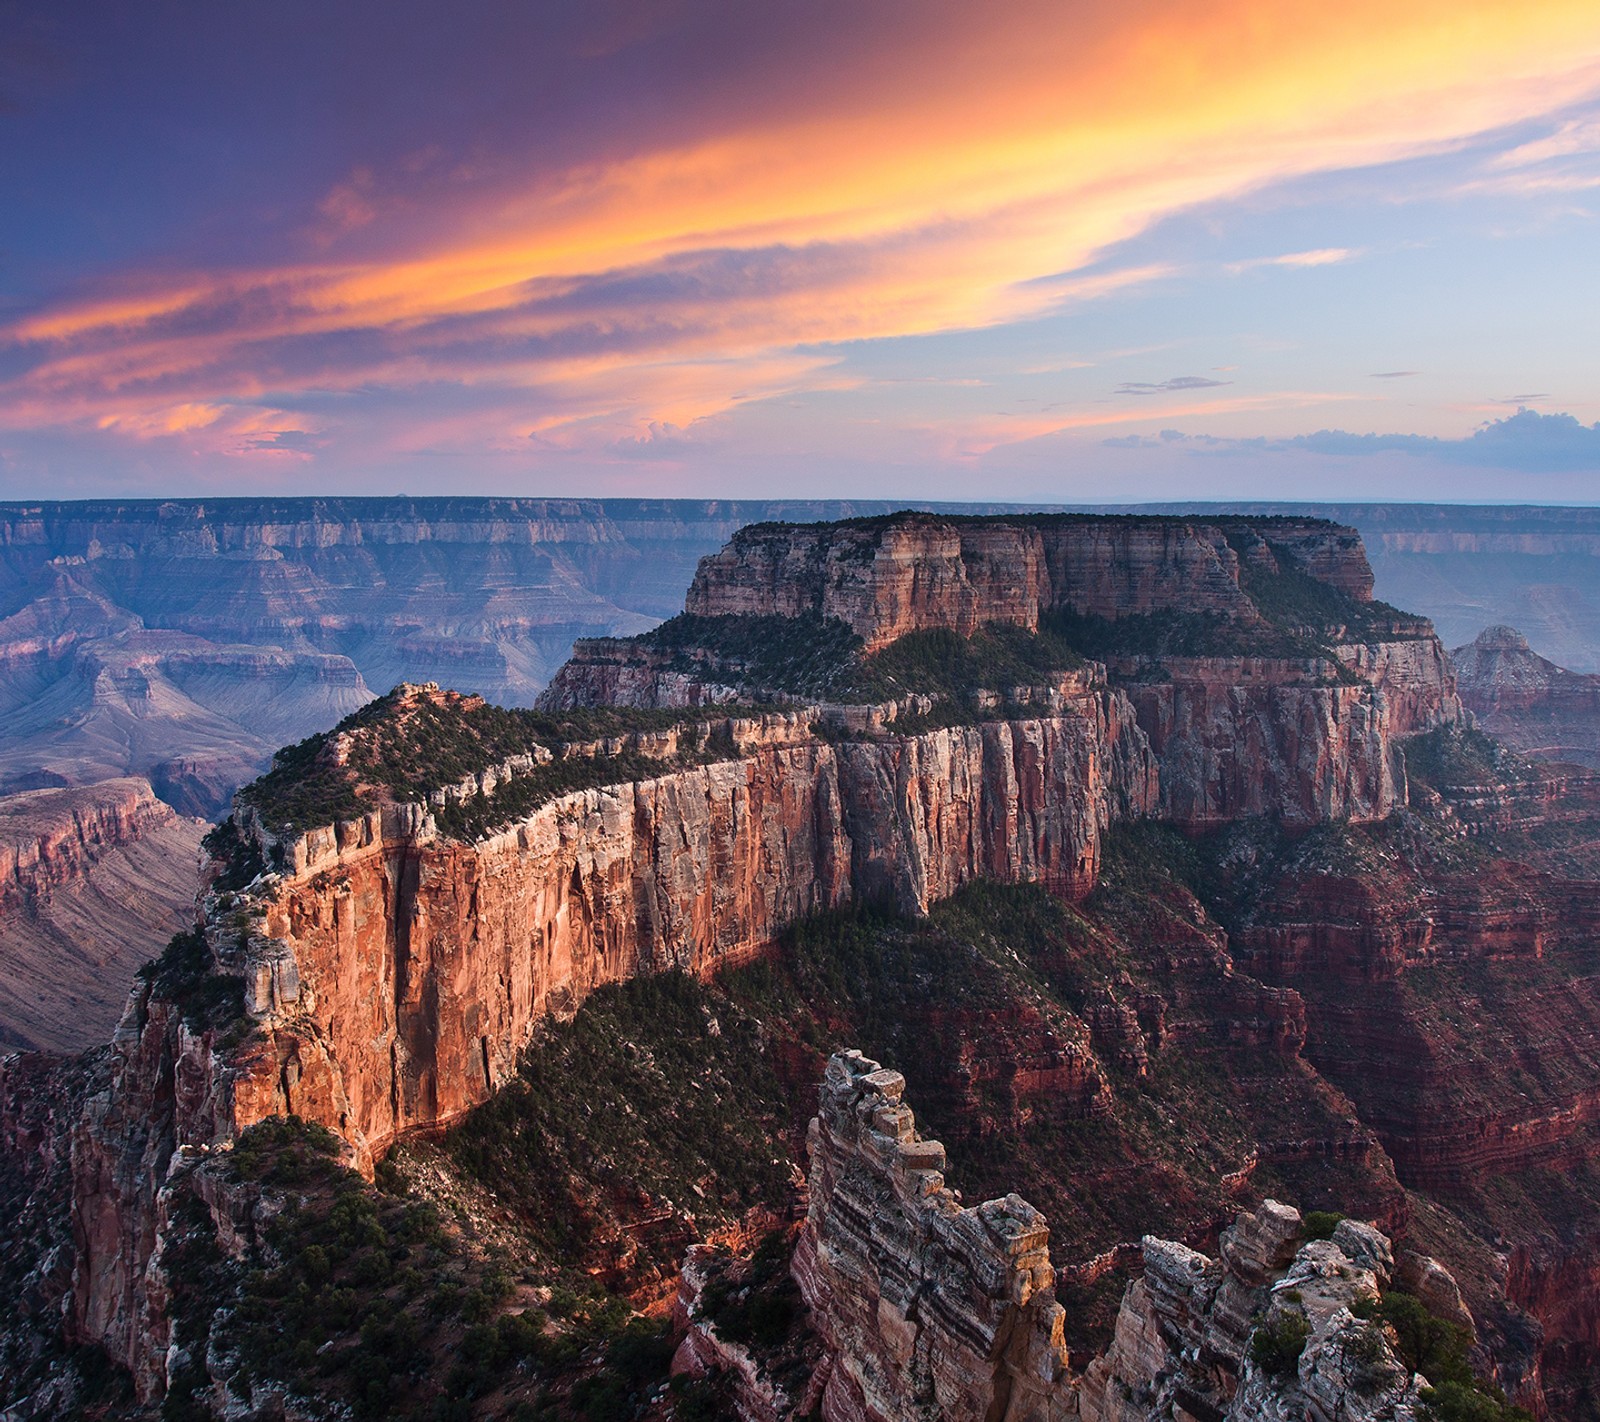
[794,1051,1446,1422]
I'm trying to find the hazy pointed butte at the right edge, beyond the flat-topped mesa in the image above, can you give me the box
[1450,627,1600,768]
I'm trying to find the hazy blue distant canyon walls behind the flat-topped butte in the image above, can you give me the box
[0,497,1574,1046]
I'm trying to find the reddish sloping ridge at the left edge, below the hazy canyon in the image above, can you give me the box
[0,779,205,1051]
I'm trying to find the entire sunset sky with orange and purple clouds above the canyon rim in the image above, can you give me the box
[0,0,1600,504]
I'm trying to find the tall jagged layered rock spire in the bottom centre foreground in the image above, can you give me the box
[794,1053,1070,1422]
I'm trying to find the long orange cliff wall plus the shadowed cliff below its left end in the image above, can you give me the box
[75,691,1155,1387]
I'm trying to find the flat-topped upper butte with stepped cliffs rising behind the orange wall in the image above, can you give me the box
[541,513,1461,829]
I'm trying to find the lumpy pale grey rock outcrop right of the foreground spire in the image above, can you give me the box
[1080,1200,1426,1422]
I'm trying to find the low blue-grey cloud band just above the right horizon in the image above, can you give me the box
[1102,409,1600,473]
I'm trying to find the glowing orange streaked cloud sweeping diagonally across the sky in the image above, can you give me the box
[0,0,1600,435]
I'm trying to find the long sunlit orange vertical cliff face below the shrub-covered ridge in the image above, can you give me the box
[238,696,1154,1156]
